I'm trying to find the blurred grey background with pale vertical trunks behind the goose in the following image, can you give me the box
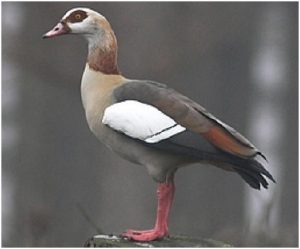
[2,2,298,247]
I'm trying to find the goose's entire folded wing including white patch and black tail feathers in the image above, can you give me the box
[102,81,275,189]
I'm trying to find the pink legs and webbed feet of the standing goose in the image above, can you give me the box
[122,180,175,241]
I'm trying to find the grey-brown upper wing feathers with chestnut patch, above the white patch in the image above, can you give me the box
[114,80,265,158]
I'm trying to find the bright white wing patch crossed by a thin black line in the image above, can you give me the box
[102,100,186,143]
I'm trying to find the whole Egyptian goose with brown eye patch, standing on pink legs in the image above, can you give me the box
[43,8,275,241]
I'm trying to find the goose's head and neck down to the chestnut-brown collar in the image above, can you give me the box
[43,8,119,74]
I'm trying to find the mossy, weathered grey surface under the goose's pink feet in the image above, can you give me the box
[84,234,231,247]
